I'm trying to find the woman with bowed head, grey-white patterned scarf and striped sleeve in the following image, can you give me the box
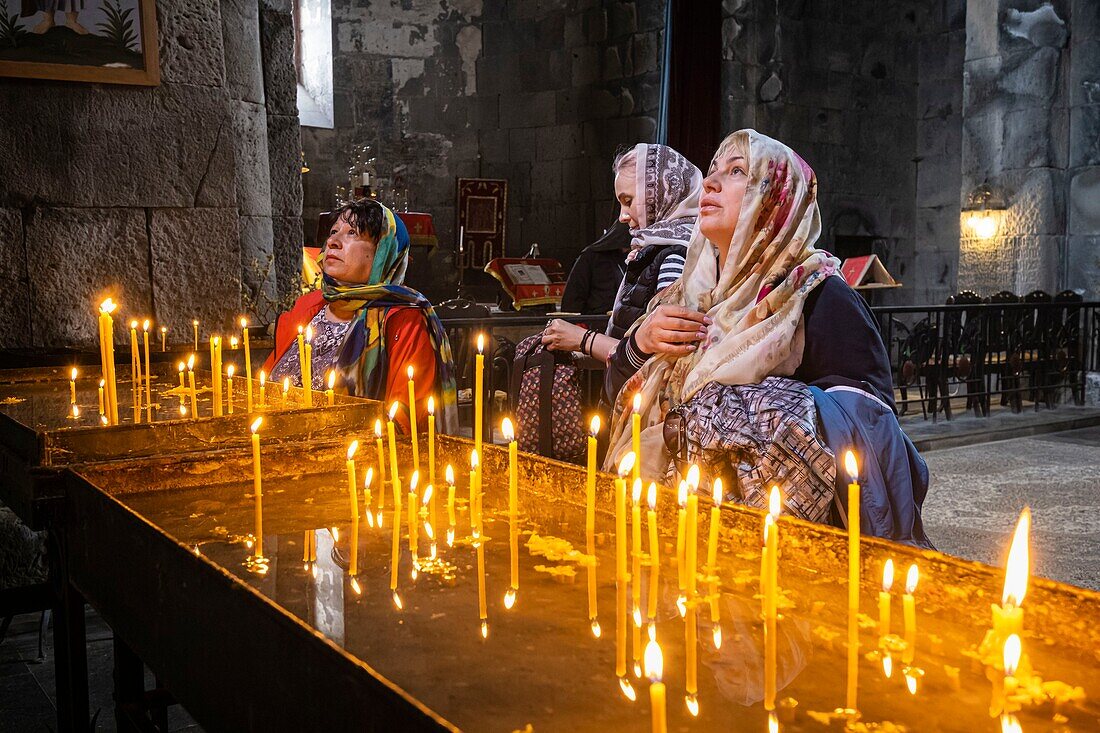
[542,143,703,361]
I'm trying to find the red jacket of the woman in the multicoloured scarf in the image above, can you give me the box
[263,291,439,433]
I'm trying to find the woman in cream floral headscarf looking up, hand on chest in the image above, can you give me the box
[605,130,928,546]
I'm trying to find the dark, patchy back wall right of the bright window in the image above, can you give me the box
[303,0,664,299]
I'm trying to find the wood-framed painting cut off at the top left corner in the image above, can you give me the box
[0,0,161,86]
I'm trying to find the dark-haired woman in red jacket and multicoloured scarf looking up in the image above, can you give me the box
[264,199,458,433]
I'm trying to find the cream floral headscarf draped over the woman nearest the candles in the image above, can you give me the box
[604,130,839,479]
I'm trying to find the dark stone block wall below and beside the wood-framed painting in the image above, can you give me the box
[0,0,300,347]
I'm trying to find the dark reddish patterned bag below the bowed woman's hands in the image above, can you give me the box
[510,332,585,463]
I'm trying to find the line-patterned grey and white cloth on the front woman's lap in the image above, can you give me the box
[664,376,836,523]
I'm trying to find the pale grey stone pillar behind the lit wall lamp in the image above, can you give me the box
[958,0,1069,295]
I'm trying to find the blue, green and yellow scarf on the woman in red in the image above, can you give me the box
[321,204,459,434]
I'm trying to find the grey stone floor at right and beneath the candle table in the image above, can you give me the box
[0,406,1100,733]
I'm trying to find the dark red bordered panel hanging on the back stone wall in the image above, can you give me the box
[458,178,508,270]
